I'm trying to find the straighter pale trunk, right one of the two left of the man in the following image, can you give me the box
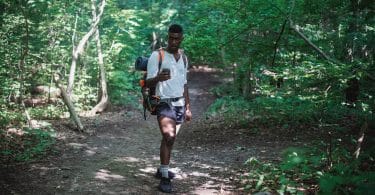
[89,0,109,115]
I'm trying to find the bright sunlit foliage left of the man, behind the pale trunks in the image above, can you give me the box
[0,0,189,126]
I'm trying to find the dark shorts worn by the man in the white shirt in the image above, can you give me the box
[156,102,185,125]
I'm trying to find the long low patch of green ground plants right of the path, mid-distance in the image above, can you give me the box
[208,88,369,131]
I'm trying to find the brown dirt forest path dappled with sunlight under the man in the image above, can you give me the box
[0,68,316,194]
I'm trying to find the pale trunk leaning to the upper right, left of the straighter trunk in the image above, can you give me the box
[66,0,105,97]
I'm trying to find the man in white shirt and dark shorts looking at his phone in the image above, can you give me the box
[146,24,192,192]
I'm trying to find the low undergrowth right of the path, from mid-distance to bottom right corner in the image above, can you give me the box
[207,80,375,194]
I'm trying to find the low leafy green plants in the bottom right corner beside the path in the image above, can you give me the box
[243,144,375,194]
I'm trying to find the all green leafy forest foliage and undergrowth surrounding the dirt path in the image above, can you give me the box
[0,3,375,194]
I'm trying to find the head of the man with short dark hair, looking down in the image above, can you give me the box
[167,24,184,53]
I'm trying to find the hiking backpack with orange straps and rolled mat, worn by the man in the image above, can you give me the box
[135,48,187,120]
